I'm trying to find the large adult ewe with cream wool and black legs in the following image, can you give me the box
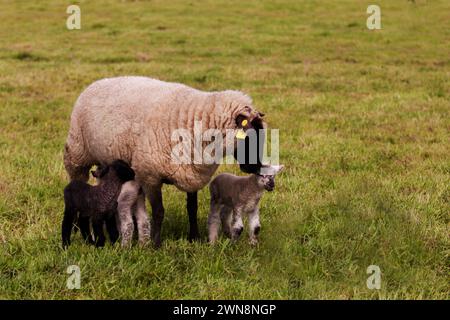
[64,77,265,246]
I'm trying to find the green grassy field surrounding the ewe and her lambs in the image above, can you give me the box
[0,0,450,299]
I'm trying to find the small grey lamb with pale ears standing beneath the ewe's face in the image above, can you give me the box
[208,165,283,245]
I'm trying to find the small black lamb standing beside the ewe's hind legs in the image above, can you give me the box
[62,160,135,248]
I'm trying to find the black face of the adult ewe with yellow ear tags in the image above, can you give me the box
[234,113,265,173]
